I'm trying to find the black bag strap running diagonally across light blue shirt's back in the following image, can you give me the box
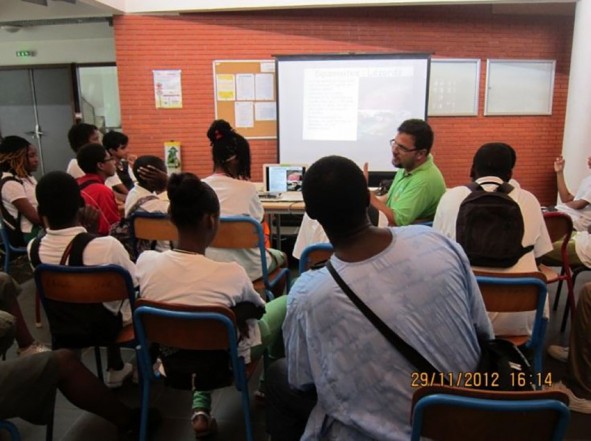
[326,260,439,374]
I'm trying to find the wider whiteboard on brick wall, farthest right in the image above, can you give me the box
[484,60,556,115]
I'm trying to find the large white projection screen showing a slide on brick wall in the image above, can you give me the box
[277,54,429,170]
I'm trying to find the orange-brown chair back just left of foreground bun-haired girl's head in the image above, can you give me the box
[129,211,179,259]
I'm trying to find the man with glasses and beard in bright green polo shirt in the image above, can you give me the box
[371,119,445,226]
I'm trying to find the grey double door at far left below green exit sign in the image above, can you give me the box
[0,67,74,177]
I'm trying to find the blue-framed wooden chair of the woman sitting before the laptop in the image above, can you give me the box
[210,216,289,300]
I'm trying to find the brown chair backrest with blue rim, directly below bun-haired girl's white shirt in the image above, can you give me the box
[134,298,236,350]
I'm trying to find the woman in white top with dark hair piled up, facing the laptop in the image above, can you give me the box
[203,120,287,281]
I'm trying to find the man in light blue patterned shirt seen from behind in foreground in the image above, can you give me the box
[266,155,492,441]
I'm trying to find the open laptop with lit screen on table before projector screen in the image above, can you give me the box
[260,164,306,202]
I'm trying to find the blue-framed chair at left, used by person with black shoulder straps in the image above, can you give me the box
[34,263,137,381]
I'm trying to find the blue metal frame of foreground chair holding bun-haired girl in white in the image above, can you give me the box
[133,299,253,441]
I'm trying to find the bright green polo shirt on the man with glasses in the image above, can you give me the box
[386,154,445,226]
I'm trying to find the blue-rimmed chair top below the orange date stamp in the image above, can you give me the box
[411,386,570,441]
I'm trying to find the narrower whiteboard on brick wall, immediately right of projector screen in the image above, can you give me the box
[429,58,480,116]
